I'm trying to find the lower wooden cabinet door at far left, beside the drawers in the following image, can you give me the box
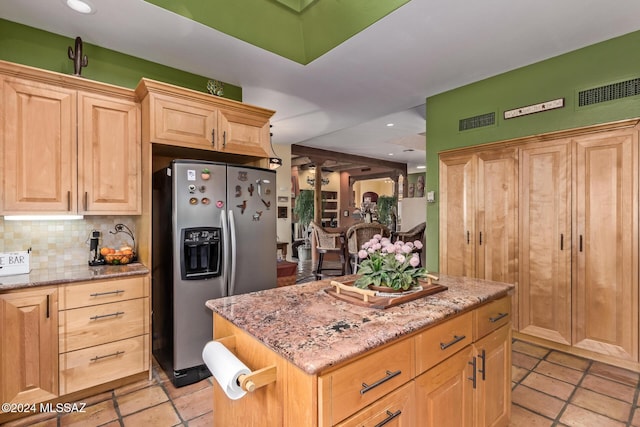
[0,288,58,403]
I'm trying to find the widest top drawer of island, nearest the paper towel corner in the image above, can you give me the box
[319,339,414,424]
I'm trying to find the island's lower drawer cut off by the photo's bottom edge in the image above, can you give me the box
[337,381,416,427]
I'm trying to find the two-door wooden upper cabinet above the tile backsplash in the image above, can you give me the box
[0,63,141,215]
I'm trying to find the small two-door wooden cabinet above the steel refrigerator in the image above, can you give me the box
[136,79,274,158]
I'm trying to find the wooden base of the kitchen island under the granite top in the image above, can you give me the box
[213,296,511,427]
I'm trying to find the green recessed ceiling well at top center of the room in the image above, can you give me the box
[146,0,410,65]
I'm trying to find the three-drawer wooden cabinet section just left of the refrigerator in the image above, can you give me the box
[59,276,149,394]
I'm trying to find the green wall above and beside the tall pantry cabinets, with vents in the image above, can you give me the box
[425,31,640,271]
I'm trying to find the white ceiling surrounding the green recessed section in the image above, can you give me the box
[0,0,640,172]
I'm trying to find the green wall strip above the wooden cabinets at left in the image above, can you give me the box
[0,19,242,101]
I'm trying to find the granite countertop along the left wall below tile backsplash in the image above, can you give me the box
[0,262,149,292]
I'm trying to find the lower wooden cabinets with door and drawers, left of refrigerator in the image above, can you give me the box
[0,276,150,424]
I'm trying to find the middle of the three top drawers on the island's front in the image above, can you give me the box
[416,312,473,374]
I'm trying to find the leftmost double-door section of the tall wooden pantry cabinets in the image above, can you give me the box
[439,148,518,327]
